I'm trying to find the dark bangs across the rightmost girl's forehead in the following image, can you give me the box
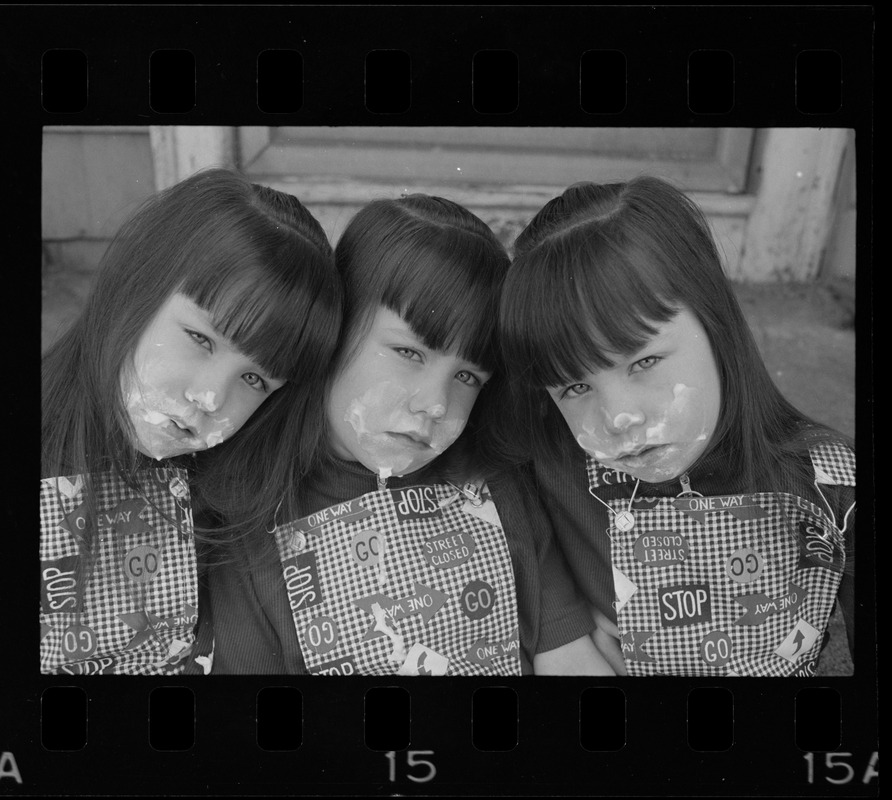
[501,229,678,387]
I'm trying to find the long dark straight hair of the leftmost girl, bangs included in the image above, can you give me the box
[41,169,341,552]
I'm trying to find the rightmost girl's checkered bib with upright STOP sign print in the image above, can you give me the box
[588,447,854,676]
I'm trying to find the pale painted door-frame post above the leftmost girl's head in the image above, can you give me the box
[149,125,236,191]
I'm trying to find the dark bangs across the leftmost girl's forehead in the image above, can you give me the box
[182,248,340,380]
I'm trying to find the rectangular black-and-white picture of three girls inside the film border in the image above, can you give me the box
[40,126,856,677]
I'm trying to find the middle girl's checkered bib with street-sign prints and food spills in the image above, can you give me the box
[276,485,520,675]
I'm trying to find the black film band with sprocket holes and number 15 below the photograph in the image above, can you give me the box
[7,678,879,796]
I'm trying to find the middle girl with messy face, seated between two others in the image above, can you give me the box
[198,195,612,675]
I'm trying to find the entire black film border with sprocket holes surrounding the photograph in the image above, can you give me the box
[0,6,879,796]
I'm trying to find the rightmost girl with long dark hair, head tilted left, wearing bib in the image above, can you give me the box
[500,177,855,676]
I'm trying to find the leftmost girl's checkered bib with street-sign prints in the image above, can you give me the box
[40,468,198,675]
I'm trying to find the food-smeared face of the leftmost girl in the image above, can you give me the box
[121,293,284,459]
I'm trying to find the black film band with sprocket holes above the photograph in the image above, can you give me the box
[3,6,873,125]
